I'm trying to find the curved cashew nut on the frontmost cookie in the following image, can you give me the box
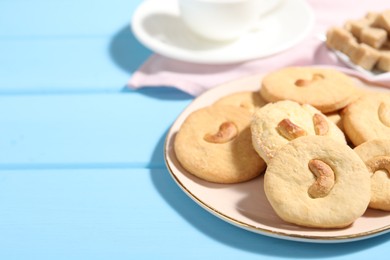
[308,159,335,199]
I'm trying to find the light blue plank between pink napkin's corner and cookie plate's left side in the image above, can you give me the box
[0,90,191,169]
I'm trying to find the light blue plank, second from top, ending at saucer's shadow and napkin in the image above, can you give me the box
[0,36,151,94]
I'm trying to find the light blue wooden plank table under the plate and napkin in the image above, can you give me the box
[0,0,390,260]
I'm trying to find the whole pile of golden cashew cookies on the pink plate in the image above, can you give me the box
[174,67,390,228]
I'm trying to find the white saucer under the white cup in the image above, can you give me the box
[131,0,314,64]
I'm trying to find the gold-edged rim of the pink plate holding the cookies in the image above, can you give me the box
[164,70,390,243]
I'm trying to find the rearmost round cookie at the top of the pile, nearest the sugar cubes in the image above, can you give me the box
[260,67,360,113]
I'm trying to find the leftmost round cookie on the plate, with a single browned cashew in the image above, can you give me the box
[174,105,265,183]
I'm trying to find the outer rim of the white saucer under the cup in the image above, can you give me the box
[130,0,315,65]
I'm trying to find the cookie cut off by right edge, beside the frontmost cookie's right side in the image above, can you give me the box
[354,139,390,211]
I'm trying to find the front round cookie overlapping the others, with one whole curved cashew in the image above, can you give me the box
[264,136,370,228]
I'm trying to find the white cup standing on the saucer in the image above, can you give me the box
[179,0,278,41]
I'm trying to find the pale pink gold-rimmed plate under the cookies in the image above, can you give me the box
[164,72,390,243]
